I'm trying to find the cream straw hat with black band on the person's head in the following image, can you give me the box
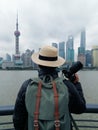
[31,46,65,67]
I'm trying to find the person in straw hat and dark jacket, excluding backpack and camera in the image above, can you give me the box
[13,46,86,130]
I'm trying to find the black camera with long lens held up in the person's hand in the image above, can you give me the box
[62,61,83,82]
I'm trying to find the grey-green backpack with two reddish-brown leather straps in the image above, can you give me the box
[25,77,70,130]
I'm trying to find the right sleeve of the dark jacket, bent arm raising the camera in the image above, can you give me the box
[64,80,86,114]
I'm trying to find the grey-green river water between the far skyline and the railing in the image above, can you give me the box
[0,70,98,106]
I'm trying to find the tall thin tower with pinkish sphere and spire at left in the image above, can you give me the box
[14,16,20,59]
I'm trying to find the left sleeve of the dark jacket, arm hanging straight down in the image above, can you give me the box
[13,79,31,130]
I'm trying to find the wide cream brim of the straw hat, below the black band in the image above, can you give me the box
[31,53,65,67]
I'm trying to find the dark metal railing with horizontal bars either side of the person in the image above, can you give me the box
[0,104,98,130]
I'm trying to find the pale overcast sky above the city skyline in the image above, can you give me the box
[0,0,98,56]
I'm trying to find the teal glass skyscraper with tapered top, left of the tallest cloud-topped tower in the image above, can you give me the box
[66,35,74,63]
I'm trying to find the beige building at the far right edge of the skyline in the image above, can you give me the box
[92,46,98,67]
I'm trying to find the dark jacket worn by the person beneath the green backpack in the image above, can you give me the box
[13,70,86,130]
